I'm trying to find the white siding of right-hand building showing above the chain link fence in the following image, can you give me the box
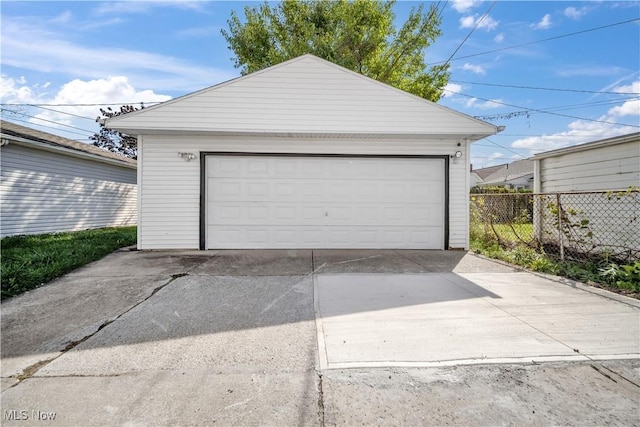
[536,139,640,193]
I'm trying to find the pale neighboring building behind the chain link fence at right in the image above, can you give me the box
[533,132,640,260]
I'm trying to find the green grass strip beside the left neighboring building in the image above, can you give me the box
[0,226,137,299]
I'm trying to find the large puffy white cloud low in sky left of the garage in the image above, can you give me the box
[0,76,171,137]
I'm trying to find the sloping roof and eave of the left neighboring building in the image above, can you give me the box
[0,120,137,168]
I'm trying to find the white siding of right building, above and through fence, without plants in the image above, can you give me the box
[534,134,640,254]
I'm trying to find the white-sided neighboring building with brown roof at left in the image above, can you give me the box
[0,121,137,237]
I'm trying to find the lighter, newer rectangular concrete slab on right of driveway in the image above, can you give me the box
[314,272,640,369]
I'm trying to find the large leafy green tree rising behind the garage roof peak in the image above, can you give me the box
[222,0,449,101]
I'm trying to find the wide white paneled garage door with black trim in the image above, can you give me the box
[205,155,445,249]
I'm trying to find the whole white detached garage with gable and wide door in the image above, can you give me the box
[107,55,497,249]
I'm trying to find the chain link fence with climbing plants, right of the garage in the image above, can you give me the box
[470,189,640,264]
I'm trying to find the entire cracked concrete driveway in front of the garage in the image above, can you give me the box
[1,250,640,426]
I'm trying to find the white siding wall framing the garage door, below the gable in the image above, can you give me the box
[138,135,468,249]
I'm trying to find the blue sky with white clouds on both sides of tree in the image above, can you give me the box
[0,0,640,169]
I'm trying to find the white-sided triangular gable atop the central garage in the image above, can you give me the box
[106,54,498,140]
